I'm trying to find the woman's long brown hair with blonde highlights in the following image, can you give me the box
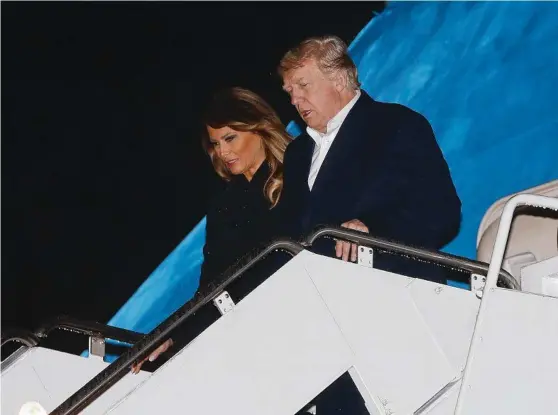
[202,87,292,208]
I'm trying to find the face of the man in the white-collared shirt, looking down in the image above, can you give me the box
[283,59,343,132]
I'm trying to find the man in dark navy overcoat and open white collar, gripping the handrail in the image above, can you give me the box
[278,36,461,283]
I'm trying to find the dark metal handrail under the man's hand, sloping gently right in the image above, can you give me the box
[304,226,519,290]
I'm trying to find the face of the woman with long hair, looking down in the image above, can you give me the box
[207,126,265,180]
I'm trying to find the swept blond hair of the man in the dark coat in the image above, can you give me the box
[277,36,360,89]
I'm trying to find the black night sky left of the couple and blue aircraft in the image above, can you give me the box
[1,2,383,329]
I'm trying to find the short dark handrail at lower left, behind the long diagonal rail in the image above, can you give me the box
[35,316,145,344]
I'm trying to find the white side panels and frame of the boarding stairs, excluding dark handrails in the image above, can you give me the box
[2,194,558,415]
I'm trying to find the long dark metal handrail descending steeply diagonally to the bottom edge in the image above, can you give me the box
[50,240,304,415]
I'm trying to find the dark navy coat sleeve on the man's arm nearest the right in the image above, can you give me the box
[357,111,461,249]
